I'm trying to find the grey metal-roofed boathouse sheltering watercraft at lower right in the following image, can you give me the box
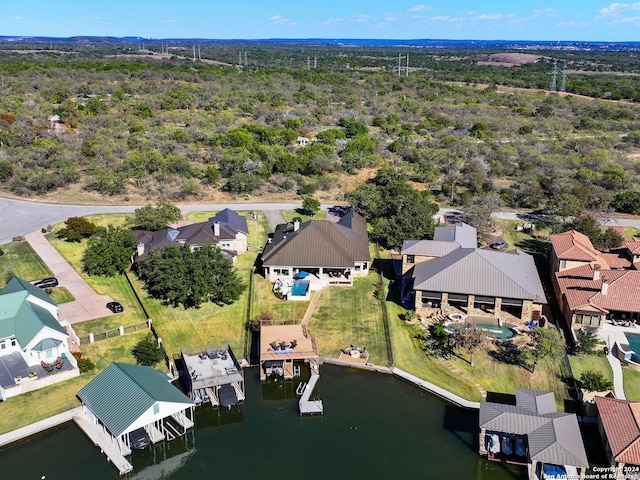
[479,388,589,480]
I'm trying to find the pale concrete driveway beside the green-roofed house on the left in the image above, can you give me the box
[25,232,113,323]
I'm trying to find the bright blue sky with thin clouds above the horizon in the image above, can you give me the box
[0,0,640,42]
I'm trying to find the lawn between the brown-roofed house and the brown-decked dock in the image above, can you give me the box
[309,273,388,365]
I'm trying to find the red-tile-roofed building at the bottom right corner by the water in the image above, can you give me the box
[595,397,640,480]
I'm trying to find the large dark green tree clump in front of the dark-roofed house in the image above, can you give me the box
[137,243,245,308]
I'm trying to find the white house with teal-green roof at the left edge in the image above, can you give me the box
[0,277,79,399]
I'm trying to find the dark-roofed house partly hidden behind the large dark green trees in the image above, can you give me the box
[134,208,249,260]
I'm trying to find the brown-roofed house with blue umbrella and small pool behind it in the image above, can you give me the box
[261,211,371,286]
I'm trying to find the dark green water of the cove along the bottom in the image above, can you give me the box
[0,365,526,480]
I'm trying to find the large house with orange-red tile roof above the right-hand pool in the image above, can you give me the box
[549,230,640,329]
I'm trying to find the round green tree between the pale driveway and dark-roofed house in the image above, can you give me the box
[82,225,137,277]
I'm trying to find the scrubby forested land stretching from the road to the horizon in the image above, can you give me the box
[0,45,640,215]
